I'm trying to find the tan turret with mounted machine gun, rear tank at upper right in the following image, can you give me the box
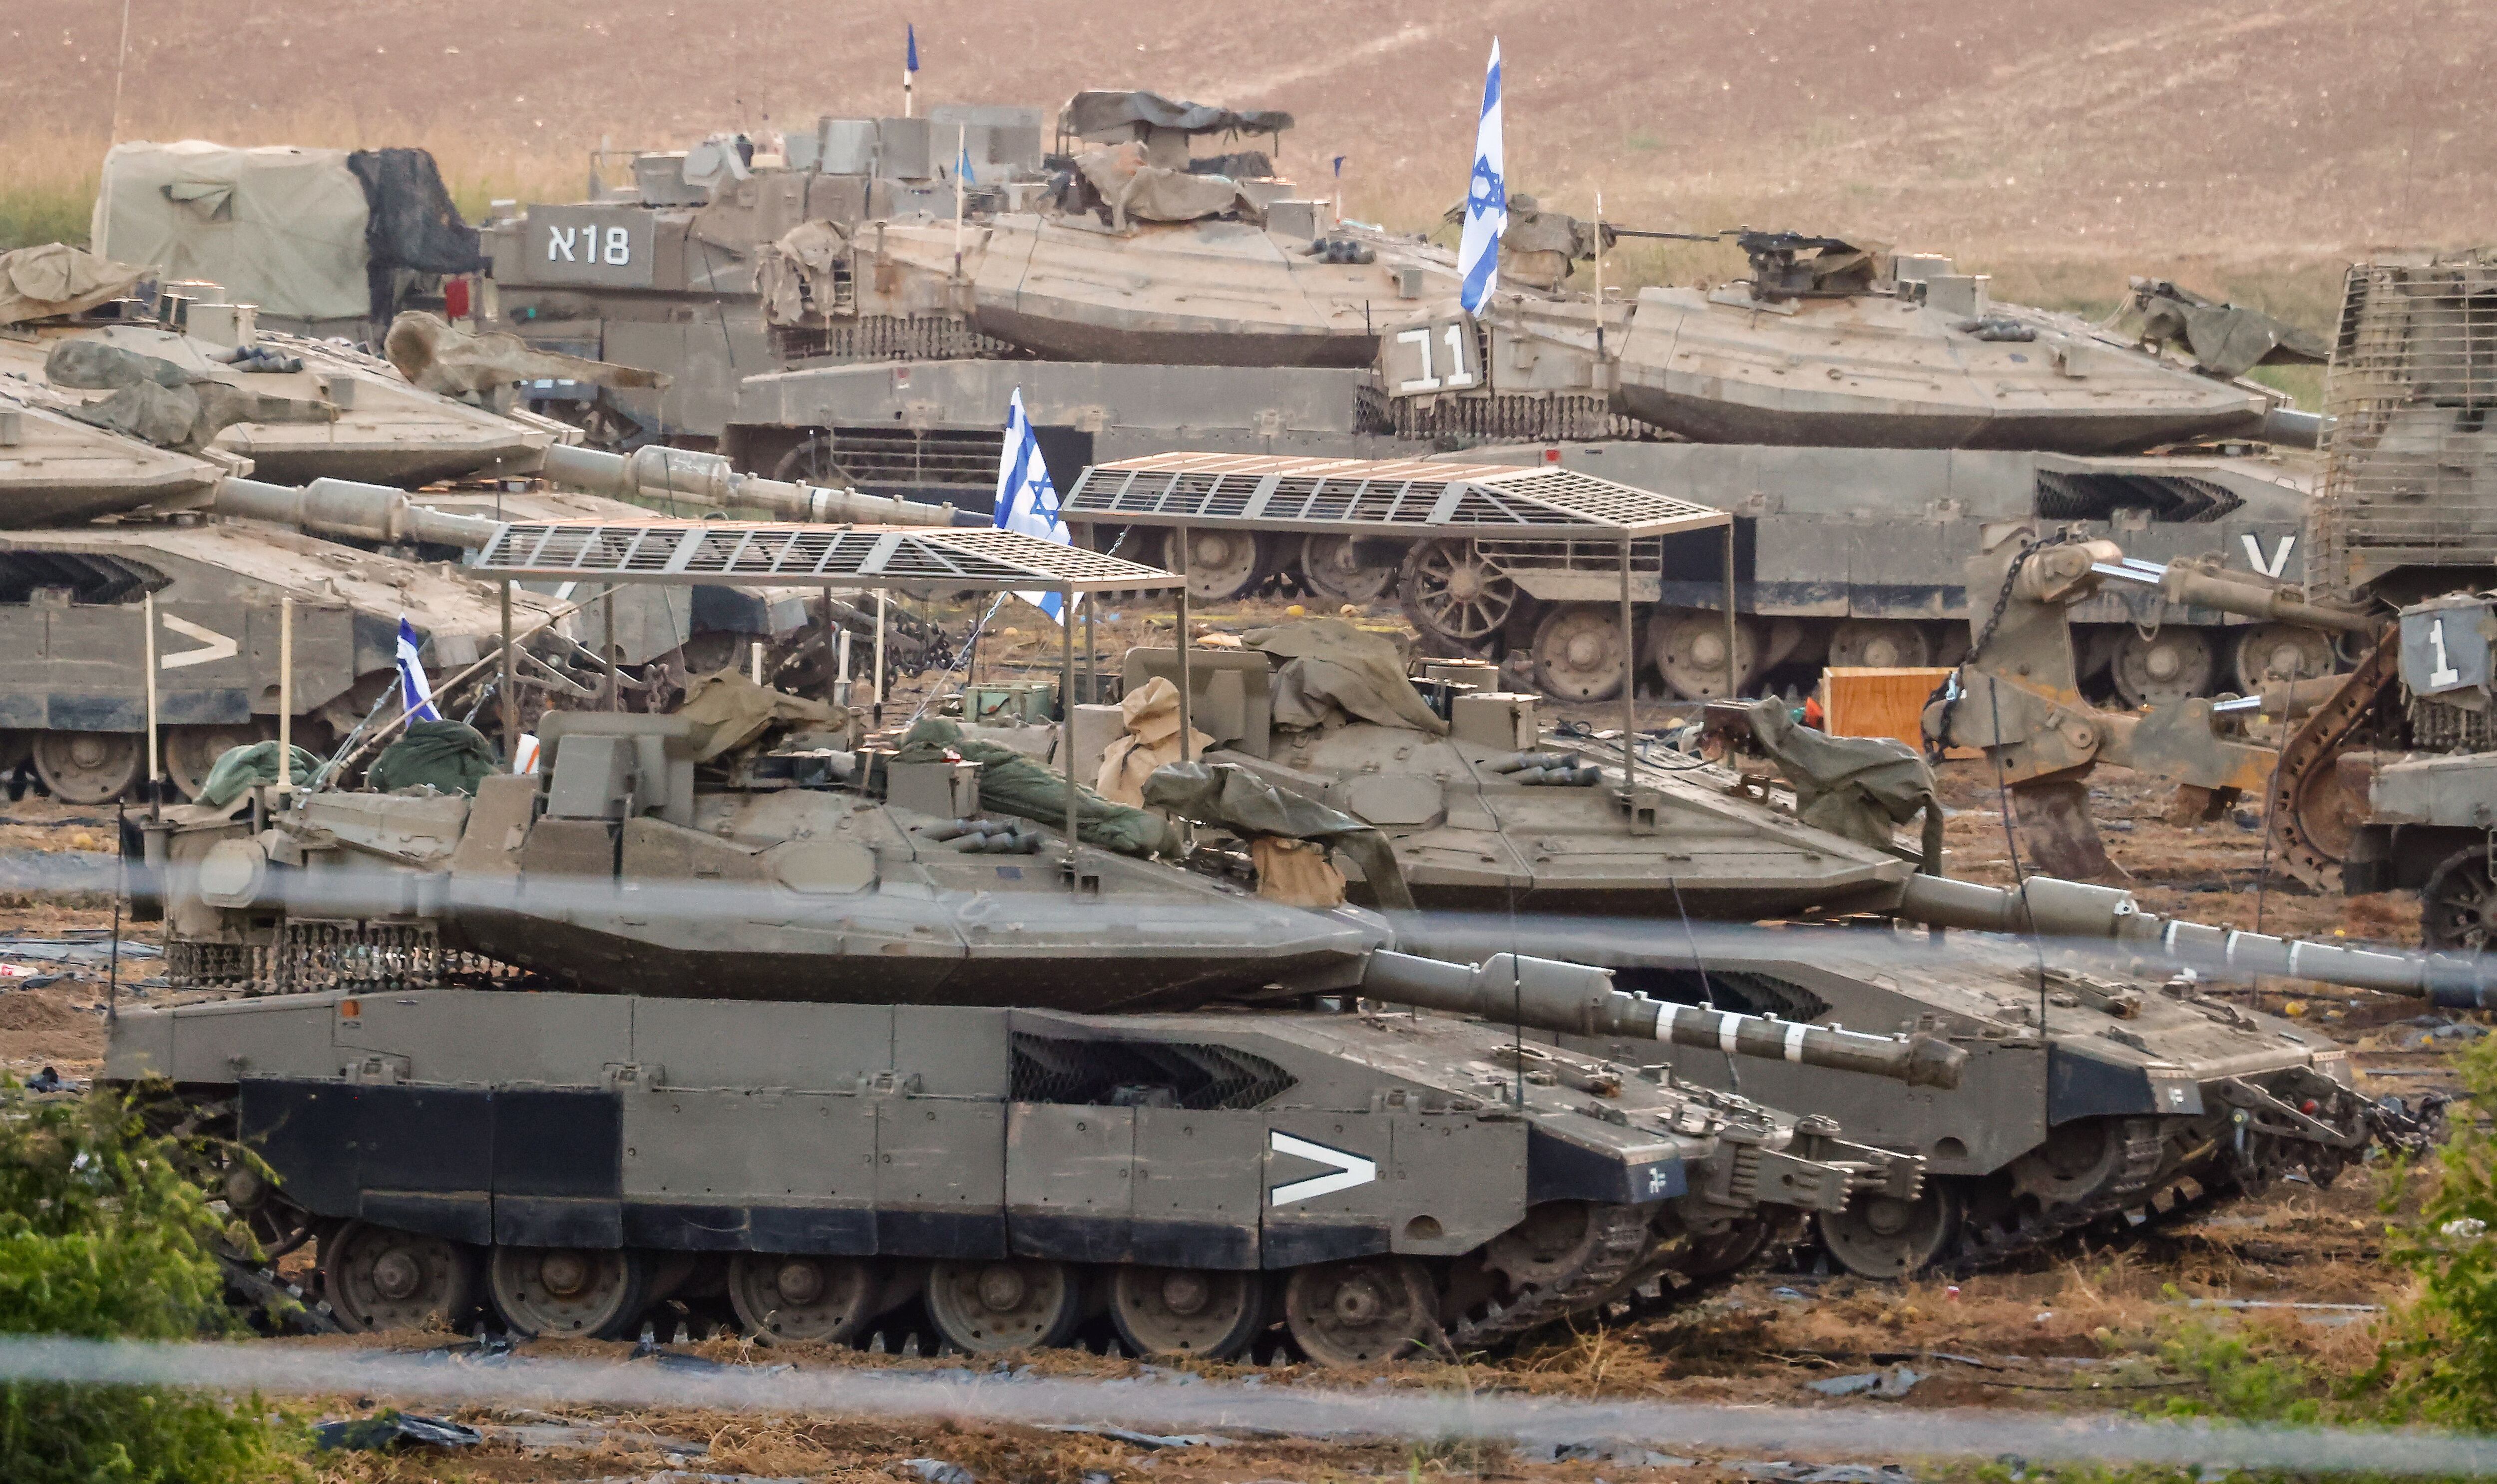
[1616,232,2325,455]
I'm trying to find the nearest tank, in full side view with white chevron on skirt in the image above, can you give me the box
[107,699,1938,1364]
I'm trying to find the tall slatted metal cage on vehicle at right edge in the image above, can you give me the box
[2310,257,2497,602]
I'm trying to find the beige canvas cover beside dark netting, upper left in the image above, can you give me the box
[90,140,372,320]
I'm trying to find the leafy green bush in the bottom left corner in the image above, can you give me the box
[0,1084,295,1484]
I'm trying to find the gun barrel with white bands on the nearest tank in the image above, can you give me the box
[1361,949,1968,1087]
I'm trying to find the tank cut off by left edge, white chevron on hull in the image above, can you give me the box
[0,387,554,804]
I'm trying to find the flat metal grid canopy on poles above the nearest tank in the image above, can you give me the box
[472,520,1179,592]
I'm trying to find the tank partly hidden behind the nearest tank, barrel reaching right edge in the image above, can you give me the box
[1126,622,2485,1277]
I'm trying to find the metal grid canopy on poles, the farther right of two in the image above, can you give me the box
[1059,452,1733,540]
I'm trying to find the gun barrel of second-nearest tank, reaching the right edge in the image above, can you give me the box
[1898,874,2497,1009]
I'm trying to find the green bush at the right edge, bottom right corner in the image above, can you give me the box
[2370,1037,2497,1429]
